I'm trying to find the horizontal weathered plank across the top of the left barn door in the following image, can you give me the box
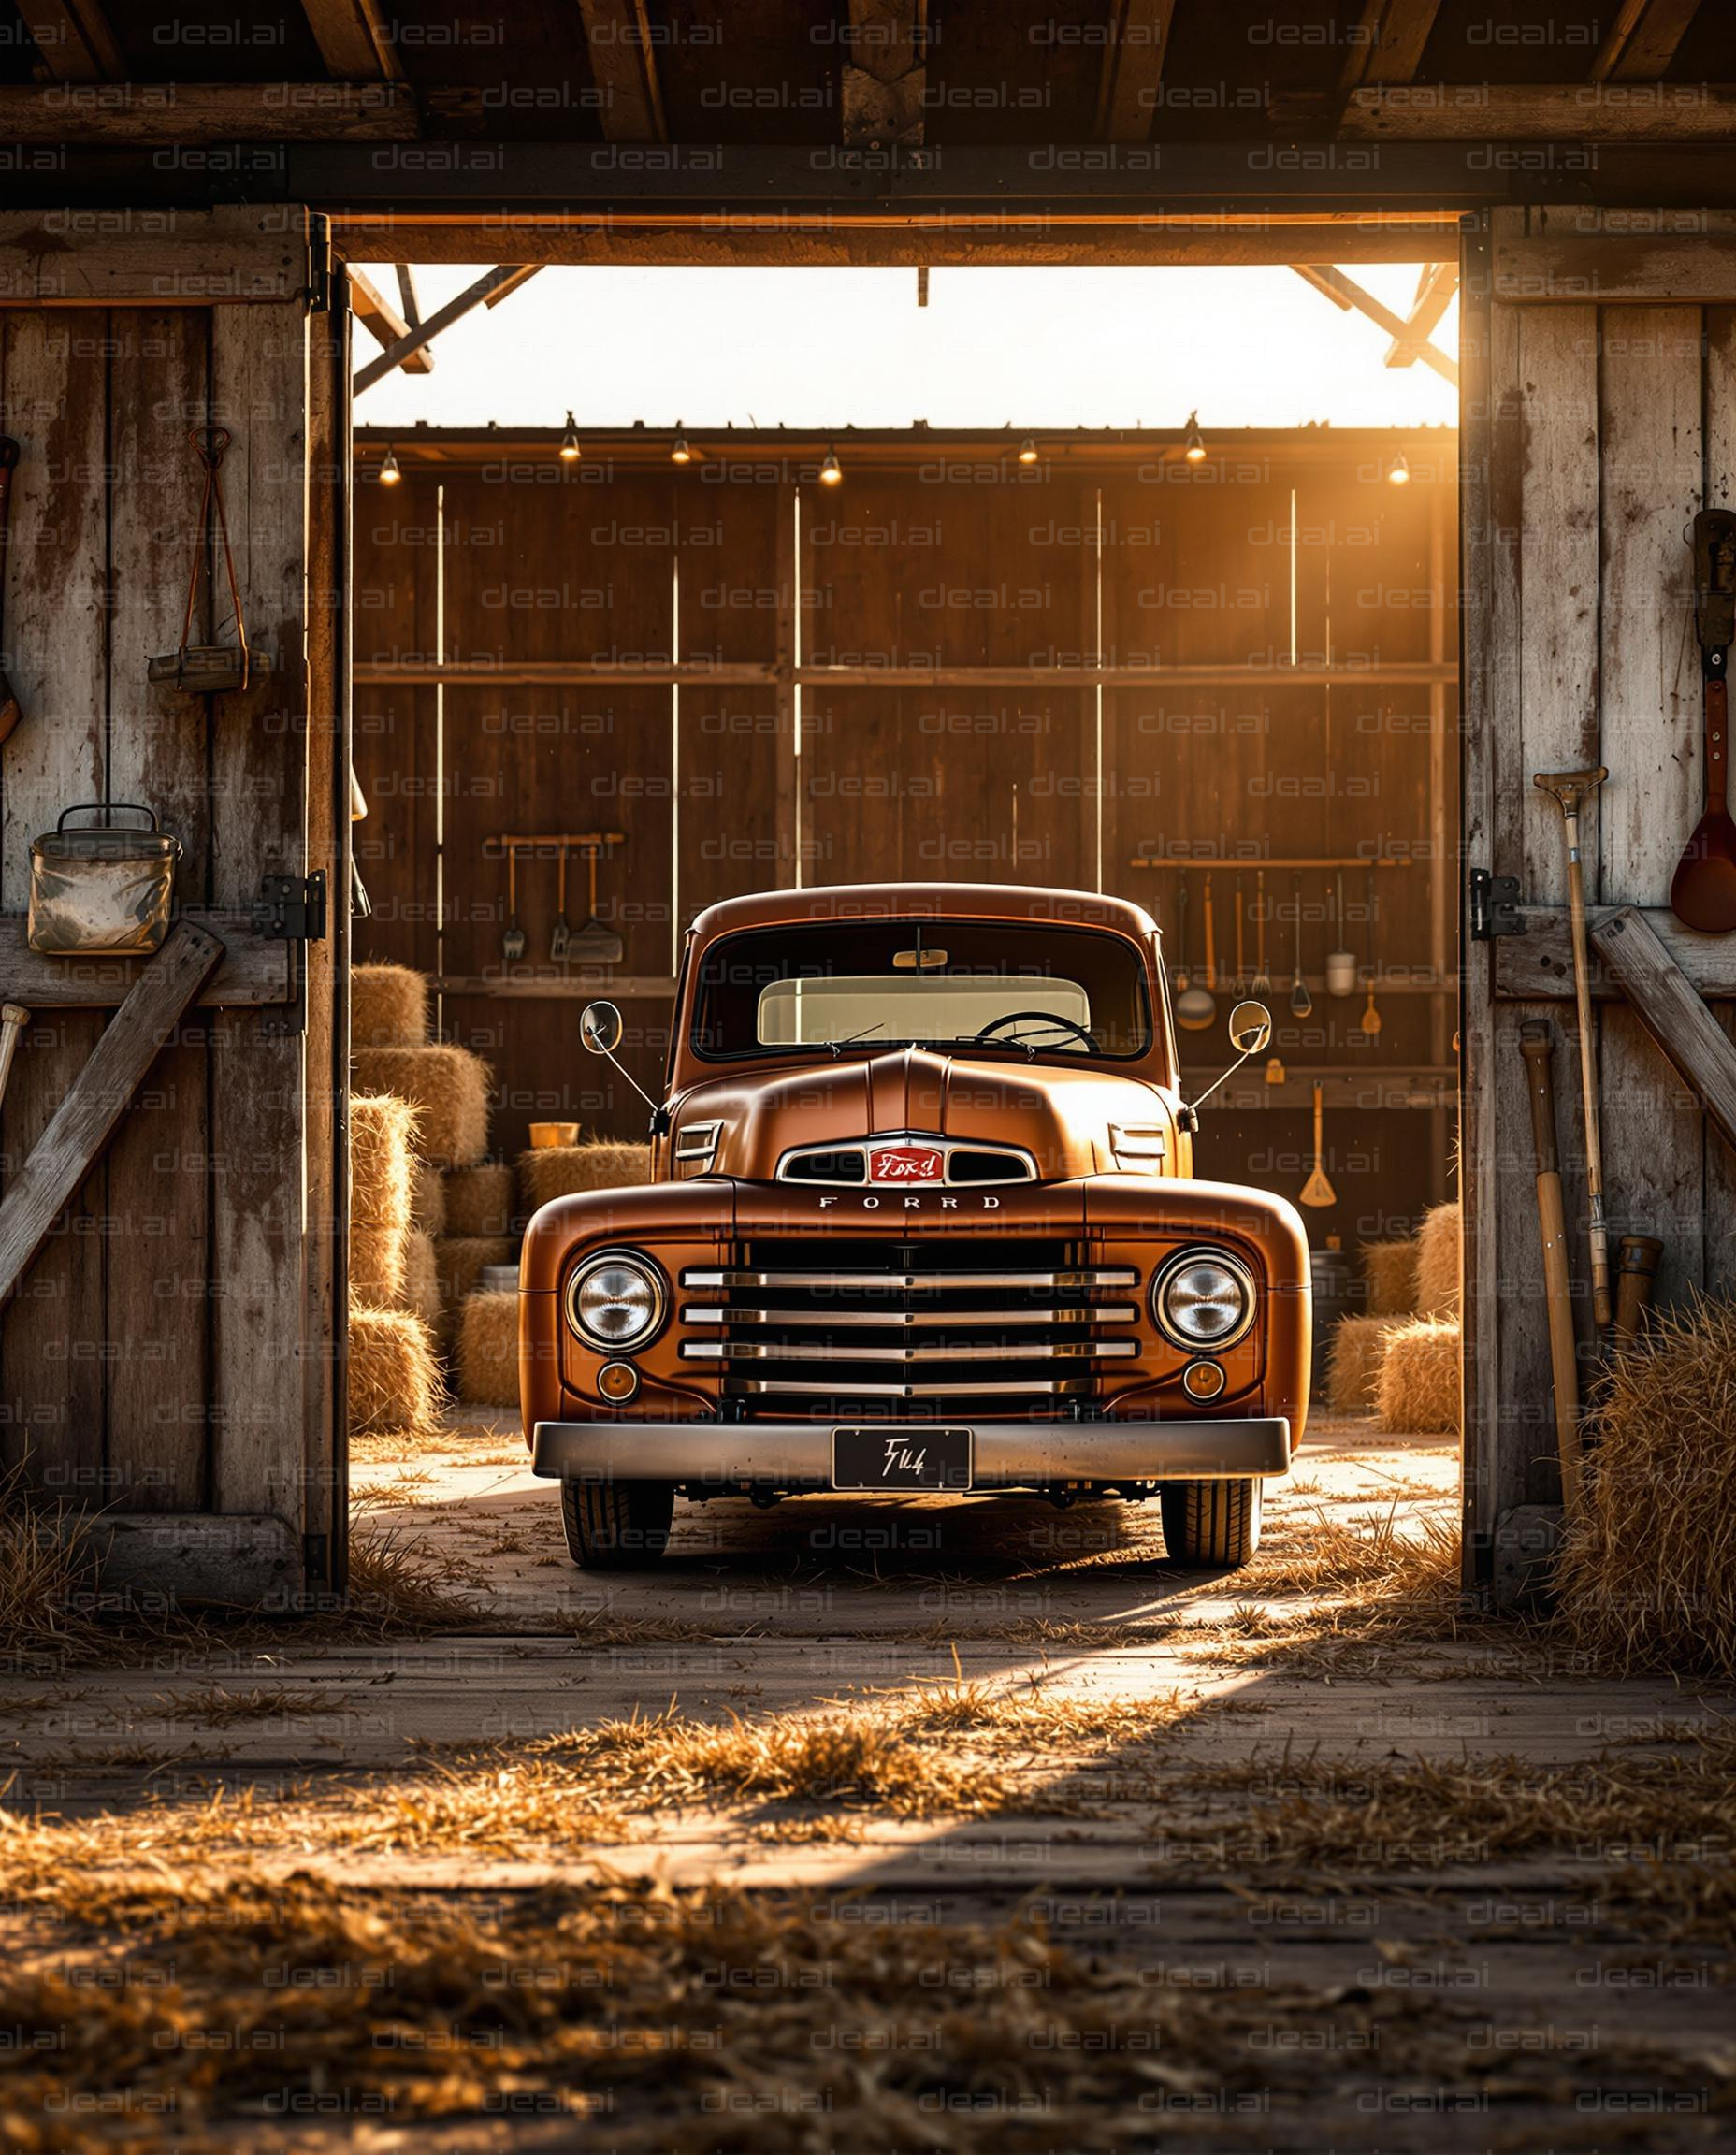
[0,205,308,306]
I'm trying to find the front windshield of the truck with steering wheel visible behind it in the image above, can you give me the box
[693,920,1150,1061]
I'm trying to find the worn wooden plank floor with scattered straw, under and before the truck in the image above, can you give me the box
[0,1418,1736,2150]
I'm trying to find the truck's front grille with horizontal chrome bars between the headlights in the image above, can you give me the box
[681,1237,1139,1420]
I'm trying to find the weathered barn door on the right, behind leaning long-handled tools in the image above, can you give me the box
[1463,209,1736,1595]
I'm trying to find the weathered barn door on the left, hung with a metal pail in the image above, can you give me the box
[0,207,349,1603]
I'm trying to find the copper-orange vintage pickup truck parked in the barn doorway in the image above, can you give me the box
[519,884,1311,1569]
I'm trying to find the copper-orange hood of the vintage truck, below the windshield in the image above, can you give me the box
[674,1048,1176,1183]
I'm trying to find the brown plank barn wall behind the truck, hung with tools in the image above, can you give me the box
[355,428,1458,1248]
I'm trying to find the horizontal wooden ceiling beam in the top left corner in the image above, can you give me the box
[0,82,418,149]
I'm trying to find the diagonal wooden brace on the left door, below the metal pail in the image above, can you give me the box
[0,920,224,1302]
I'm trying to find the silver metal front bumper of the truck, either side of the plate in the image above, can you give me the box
[532,1413,1290,1494]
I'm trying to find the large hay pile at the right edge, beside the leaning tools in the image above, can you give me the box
[1555,1299,1736,1685]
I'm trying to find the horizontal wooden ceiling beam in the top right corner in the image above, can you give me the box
[1338,82,1736,147]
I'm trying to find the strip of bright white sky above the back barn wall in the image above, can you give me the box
[355,263,1458,428]
